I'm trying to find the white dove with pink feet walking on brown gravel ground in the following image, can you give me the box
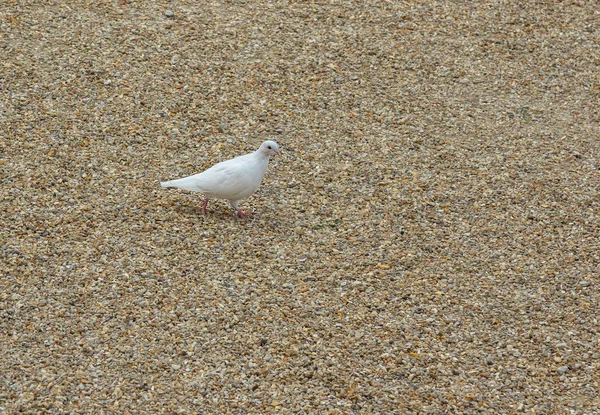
[160,140,281,218]
